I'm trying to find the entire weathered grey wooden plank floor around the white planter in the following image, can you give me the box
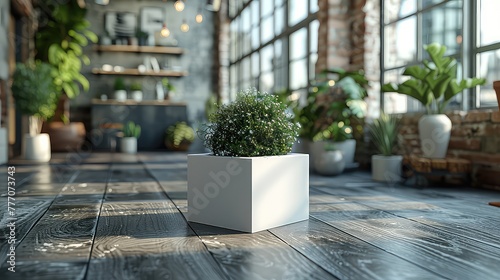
[0,153,500,280]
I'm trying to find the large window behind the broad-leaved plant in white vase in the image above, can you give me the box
[381,0,500,113]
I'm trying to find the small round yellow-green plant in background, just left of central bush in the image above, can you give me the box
[165,122,194,151]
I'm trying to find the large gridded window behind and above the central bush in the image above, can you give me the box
[229,0,319,98]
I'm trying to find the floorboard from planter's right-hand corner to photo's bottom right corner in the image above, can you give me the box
[311,188,500,279]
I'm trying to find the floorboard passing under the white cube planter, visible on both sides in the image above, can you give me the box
[146,163,336,279]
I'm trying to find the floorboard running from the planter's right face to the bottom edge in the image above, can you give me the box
[269,218,440,279]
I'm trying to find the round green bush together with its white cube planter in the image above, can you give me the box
[188,91,309,232]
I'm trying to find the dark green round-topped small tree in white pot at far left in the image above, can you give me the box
[12,61,58,162]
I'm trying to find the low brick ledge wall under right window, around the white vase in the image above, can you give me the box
[400,110,500,188]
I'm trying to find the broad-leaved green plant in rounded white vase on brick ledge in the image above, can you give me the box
[382,43,486,158]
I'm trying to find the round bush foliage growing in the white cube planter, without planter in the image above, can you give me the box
[203,90,299,157]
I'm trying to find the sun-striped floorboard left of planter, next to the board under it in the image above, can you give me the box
[87,164,225,279]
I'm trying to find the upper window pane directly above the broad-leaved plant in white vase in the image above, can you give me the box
[422,0,462,55]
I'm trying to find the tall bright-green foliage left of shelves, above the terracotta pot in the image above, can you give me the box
[35,0,97,98]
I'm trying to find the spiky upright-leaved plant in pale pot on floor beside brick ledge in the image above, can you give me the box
[368,112,403,182]
